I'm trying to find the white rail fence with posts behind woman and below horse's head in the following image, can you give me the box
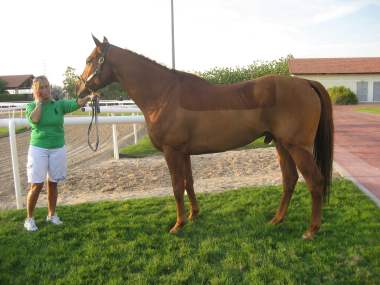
[0,107,145,209]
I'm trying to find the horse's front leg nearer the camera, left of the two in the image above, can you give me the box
[163,146,186,233]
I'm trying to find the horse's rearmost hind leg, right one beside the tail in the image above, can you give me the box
[286,145,323,239]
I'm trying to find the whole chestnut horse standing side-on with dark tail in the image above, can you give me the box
[76,37,333,239]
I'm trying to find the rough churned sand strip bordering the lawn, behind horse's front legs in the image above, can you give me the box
[55,145,281,204]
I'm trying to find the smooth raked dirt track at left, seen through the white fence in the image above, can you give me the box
[0,124,144,209]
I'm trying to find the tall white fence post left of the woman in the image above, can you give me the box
[8,119,22,209]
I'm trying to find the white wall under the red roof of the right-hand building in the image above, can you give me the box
[296,74,380,102]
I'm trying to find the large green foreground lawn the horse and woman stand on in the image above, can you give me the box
[0,180,380,284]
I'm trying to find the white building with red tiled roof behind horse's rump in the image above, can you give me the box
[289,57,380,103]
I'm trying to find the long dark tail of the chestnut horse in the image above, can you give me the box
[309,80,334,201]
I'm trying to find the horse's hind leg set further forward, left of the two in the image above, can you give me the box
[271,142,298,224]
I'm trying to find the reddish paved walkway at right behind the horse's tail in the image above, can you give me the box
[334,105,380,206]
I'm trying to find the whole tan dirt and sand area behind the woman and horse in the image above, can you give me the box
[0,120,338,209]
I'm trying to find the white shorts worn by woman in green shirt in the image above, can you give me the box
[26,145,67,183]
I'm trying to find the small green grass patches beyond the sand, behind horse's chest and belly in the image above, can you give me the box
[120,136,273,157]
